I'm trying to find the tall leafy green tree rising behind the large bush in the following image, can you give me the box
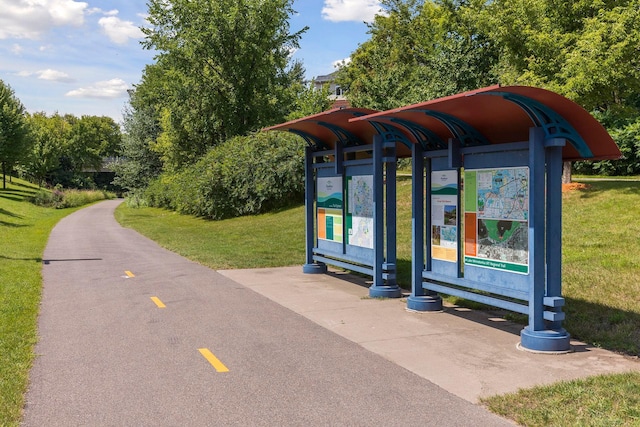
[138,0,306,169]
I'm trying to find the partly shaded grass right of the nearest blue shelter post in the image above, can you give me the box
[563,181,640,356]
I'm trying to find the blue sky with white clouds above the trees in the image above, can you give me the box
[0,0,380,123]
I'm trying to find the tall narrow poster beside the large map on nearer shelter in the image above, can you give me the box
[431,170,458,262]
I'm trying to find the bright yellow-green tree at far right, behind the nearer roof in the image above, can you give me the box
[487,0,640,174]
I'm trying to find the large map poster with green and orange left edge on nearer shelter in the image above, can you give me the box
[464,167,529,274]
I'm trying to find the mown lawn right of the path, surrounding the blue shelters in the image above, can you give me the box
[116,176,640,426]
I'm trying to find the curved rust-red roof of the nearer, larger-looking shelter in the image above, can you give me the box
[352,86,621,160]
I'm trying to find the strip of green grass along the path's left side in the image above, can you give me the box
[0,178,110,426]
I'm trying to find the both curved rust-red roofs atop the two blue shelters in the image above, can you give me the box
[266,86,621,160]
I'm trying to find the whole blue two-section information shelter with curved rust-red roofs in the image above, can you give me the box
[270,86,620,352]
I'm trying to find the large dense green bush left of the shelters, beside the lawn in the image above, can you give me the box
[145,132,304,219]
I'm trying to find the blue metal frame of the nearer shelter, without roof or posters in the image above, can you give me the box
[407,127,570,352]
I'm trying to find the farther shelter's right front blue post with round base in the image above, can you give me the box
[369,135,402,298]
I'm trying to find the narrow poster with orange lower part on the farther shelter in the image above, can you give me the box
[316,176,343,243]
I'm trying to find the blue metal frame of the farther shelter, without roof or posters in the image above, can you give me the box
[303,133,402,298]
